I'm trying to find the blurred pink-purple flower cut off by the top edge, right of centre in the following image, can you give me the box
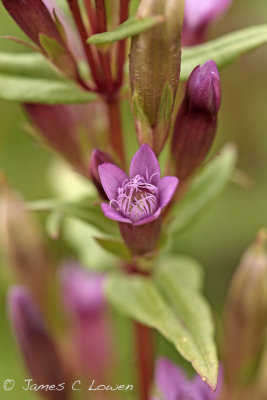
[183,0,233,46]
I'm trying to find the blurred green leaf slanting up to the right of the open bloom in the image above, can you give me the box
[169,144,237,235]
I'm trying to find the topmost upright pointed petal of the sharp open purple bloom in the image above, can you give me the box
[130,143,160,185]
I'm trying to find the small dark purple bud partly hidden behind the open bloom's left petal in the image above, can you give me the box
[89,149,114,200]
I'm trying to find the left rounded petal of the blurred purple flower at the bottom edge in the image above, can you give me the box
[155,358,187,399]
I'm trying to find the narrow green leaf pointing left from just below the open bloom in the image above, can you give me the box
[27,197,119,236]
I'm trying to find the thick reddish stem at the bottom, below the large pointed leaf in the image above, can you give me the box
[135,322,154,400]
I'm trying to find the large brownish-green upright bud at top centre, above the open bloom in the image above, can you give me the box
[130,0,184,155]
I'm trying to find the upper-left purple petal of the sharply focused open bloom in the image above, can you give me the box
[98,163,128,200]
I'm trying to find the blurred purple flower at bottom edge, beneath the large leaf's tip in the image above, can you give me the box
[151,358,222,400]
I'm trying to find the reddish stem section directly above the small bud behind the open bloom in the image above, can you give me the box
[106,98,125,167]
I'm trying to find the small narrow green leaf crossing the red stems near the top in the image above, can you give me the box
[87,15,164,46]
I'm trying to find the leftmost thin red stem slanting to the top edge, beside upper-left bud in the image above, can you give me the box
[68,0,102,88]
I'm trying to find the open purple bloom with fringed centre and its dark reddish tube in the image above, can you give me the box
[98,143,178,255]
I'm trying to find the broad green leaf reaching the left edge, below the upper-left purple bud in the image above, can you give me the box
[0,53,97,104]
